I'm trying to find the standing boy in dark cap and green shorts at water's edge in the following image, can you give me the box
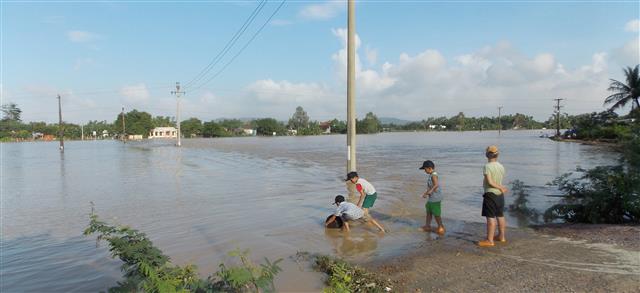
[419,161,445,235]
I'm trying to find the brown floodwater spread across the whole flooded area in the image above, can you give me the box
[0,131,617,292]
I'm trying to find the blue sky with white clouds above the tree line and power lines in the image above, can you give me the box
[1,1,640,123]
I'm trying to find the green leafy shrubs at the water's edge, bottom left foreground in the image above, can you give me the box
[84,212,281,293]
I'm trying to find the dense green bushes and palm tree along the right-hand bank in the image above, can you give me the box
[544,66,640,224]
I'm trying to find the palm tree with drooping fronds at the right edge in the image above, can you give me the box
[604,65,640,111]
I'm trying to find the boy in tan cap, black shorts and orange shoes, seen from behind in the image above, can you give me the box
[478,145,508,247]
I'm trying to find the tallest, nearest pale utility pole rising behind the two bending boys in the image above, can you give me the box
[347,0,356,172]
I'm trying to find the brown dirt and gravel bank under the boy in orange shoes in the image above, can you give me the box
[362,224,640,292]
